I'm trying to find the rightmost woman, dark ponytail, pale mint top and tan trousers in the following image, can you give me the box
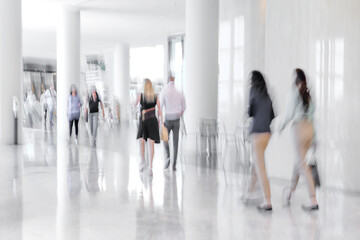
[280,68,319,211]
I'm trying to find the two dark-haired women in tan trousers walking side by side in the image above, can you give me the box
[242,68,319,211]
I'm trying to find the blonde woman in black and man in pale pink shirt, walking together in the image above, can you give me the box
[135,76,186,176]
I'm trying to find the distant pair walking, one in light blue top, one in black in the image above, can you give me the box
[67,85,105,147]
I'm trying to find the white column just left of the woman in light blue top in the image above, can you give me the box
[57,5,80,144]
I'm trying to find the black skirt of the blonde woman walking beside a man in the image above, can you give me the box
[137,117,160,143]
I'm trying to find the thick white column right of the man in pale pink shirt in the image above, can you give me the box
[185,0,219,133]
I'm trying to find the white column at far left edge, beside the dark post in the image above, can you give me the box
[0,0,23,144]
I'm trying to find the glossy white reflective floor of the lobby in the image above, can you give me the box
[0,123,360,240]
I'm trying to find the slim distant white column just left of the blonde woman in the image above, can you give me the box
[113,44,130,122]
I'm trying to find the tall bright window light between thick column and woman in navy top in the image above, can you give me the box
[218,15,246,129]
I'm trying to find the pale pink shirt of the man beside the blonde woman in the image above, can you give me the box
[160,81,186,121]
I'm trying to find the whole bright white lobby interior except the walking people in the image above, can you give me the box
[0,0,360,240]
